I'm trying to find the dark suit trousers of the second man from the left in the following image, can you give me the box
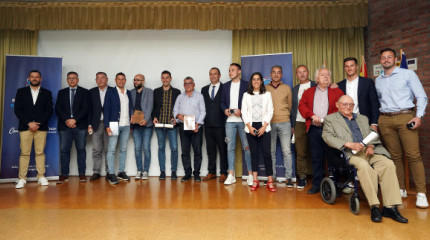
[60,128,87,177]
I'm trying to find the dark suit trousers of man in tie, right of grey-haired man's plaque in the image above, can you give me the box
[205,127,228,175]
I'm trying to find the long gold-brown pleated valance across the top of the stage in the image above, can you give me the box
[0,0,368,31]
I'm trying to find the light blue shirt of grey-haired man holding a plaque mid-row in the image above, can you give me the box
[173,91,206,125]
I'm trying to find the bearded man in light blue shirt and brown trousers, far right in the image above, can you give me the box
[375,48,429,208]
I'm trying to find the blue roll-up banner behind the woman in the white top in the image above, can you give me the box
[241,53,296,181]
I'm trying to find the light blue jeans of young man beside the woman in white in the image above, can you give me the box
[225,122,252,171]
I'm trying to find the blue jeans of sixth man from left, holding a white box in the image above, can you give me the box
[155,128,178,171]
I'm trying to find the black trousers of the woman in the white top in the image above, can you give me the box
[246,122,273,176]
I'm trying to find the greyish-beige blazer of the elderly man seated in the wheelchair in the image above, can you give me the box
[322,112,391,158]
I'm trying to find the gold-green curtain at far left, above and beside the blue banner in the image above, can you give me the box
[0,30,38,166]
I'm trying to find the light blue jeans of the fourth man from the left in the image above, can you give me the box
[106,126,130,174]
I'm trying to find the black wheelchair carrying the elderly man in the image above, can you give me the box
[320,147,360,215]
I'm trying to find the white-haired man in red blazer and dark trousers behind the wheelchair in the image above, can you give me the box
[299,68,343,194]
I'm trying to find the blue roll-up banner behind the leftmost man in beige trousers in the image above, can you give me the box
[0,55,63,182]
